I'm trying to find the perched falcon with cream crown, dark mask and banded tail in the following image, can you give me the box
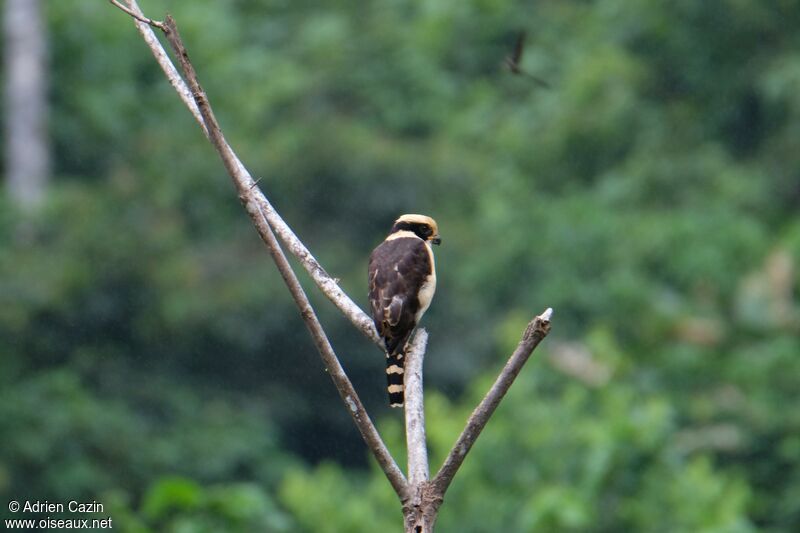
[369,215,441,407]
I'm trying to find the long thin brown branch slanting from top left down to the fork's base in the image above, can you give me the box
[112,0,408,500]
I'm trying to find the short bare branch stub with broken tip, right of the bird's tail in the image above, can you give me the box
[431,308,553,497]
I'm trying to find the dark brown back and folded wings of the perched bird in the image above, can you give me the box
[369,237,431,355]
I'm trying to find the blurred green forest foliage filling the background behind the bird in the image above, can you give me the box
[0,0,800,533]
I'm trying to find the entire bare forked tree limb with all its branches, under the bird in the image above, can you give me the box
[109,0,553,533]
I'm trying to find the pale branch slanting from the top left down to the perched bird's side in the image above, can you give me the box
[111,0,383,350]
